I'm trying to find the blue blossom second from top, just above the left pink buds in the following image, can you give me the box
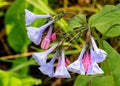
[27,20,54,45]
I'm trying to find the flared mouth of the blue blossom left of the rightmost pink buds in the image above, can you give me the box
[67,60,85,74]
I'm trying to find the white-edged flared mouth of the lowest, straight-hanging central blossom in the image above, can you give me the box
[54,66,71,78]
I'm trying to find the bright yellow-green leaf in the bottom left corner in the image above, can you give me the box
[0,70,42,86]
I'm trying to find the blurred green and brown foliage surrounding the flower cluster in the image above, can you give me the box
[0,0,120,86]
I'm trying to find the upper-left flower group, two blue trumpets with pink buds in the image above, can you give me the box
[25,9,56,49]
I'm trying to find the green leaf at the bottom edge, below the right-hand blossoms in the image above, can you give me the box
[74,75,114,86]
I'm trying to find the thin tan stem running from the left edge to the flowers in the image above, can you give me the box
[0,52,34,60]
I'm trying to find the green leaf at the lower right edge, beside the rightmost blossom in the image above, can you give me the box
[103,41,120,86]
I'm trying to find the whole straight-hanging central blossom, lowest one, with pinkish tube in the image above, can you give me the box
[54,49,71,78]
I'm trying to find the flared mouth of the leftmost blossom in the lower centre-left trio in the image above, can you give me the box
[32,52,48,65]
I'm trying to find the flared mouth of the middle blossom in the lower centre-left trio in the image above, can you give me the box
[39,63,54,77]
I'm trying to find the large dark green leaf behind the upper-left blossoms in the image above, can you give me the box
[5,0,30,52]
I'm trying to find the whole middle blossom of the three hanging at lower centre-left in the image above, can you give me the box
[39,51,58,77]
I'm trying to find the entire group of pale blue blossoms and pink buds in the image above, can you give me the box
[25,10,107,78]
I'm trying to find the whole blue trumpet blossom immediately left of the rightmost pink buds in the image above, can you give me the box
[67,45,86,74]
